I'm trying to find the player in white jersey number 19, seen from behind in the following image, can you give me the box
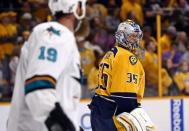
[7,0,86,131]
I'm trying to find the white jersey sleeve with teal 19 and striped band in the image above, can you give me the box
[25,30,74,121]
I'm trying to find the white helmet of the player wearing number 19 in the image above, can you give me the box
[49,0,86,20]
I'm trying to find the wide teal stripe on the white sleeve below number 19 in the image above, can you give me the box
[25,80,55,95]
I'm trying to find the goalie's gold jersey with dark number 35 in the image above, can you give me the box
[96,46,145,104]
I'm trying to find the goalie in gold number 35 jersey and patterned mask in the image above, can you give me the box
[89,20,154,131]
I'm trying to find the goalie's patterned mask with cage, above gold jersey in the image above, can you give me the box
[115,20,143,51]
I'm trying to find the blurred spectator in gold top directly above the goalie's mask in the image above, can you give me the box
[120,0,144,25]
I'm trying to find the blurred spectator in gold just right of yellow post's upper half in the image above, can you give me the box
[160,26,177,53]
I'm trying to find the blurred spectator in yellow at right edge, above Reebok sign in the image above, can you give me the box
[174,61,189,95]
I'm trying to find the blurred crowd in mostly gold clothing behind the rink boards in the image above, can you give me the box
[0,0,189,101]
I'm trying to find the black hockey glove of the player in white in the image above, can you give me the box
[45,103,75,131]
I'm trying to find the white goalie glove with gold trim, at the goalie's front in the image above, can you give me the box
[116,108,155,131]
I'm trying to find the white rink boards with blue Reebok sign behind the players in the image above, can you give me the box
[0,97,189,131]
